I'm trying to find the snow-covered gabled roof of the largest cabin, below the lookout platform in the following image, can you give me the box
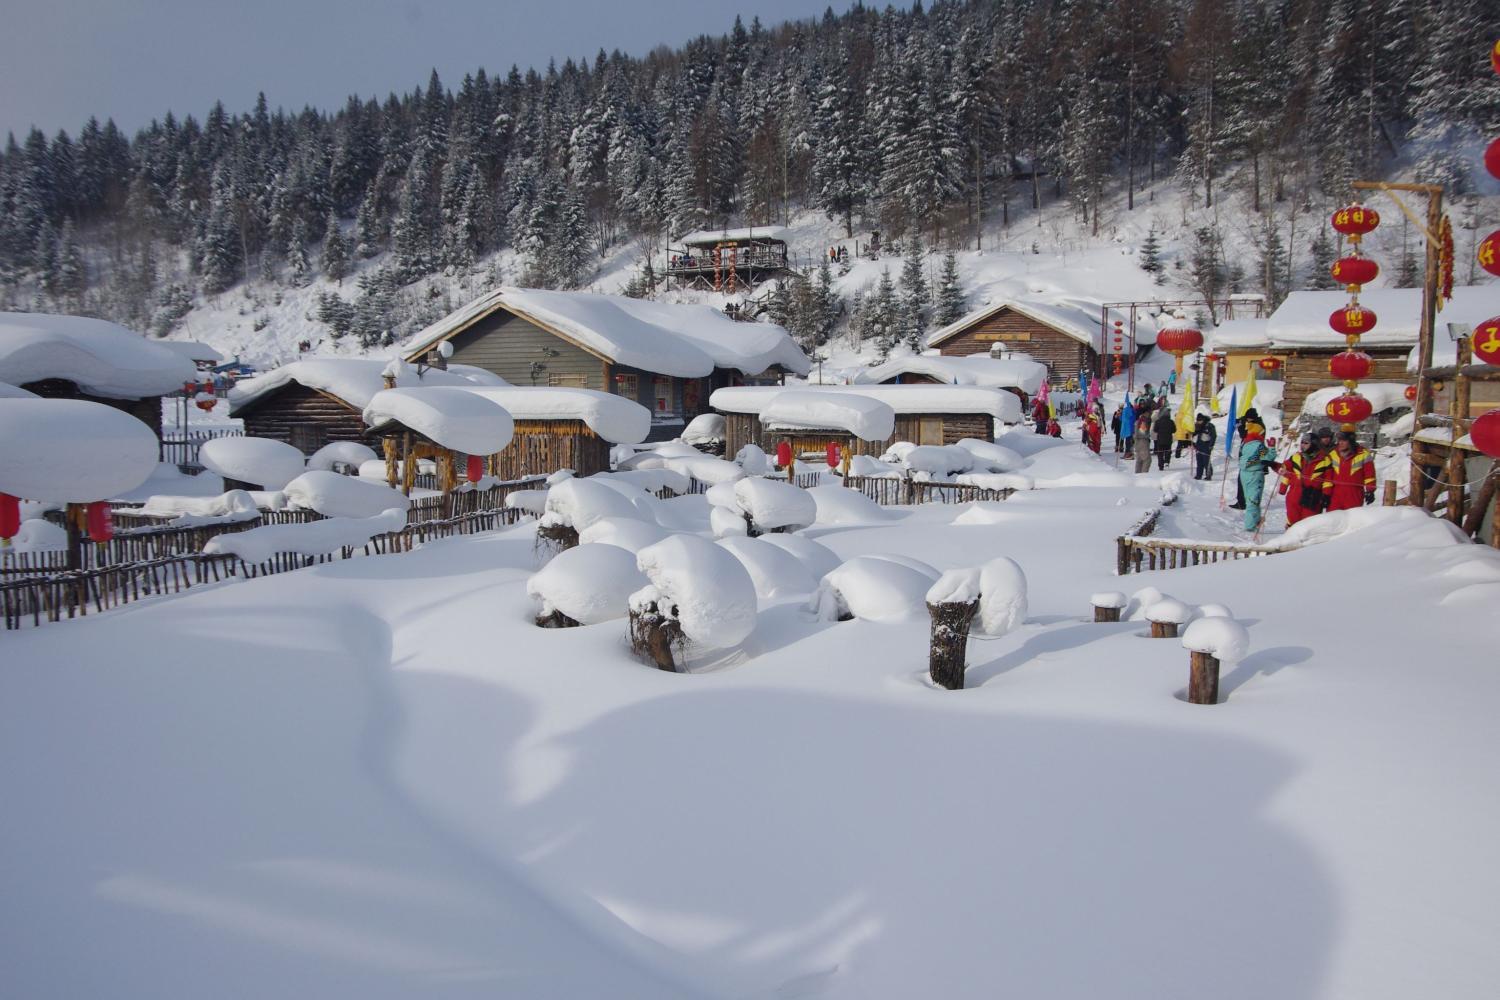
[402,288,812,378]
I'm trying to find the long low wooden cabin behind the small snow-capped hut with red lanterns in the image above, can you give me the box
[714,384,1022,456]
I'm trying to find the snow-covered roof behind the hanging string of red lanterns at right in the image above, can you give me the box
[1266,282,1500,351]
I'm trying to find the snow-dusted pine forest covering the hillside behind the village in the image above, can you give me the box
[0,0,1497,352]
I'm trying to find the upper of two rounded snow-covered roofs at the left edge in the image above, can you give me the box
[0,312,198,399]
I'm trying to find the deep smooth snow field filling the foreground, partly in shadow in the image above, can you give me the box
[0,433,1500,1000]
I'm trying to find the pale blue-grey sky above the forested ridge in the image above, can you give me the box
[0,0,849,138]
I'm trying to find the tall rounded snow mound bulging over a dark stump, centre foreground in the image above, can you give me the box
[630,535,756,649]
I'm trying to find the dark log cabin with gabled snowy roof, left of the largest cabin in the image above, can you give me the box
[230,358,503,456]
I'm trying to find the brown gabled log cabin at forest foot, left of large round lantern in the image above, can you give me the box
[927,300,1101,382]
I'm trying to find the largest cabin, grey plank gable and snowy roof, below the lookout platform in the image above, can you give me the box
[402,288,809,441]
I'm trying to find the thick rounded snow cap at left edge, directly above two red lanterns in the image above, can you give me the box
[0,399,161,504]
